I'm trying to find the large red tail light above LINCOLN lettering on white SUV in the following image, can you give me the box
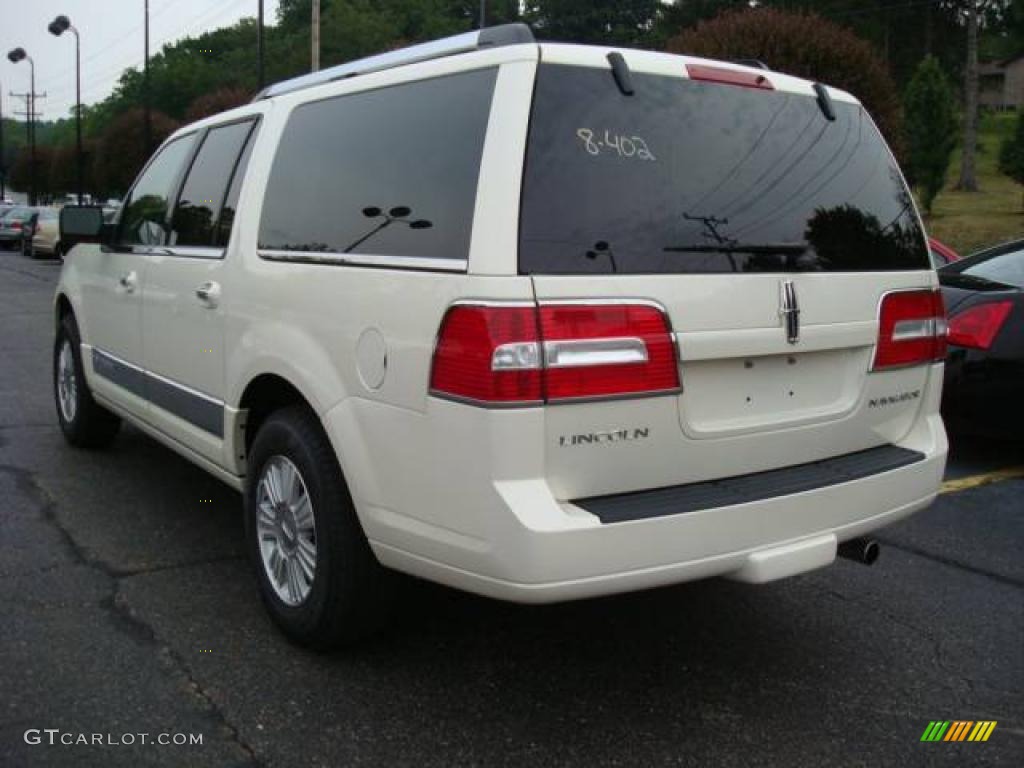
[430,303,679,406]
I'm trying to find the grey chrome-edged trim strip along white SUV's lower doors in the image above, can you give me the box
[92,347,224,438]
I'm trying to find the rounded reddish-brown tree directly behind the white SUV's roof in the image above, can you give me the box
[667,8,903,156]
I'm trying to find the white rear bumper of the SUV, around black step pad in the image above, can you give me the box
[360,413,947,603]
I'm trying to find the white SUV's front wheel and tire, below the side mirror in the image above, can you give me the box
[53,314,121,449]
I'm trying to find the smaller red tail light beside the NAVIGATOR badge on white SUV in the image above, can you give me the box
[871,291,946,371]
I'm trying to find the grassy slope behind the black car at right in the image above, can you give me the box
[925,113,1024,256]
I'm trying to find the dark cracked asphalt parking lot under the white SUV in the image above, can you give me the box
[0,252,1024,768]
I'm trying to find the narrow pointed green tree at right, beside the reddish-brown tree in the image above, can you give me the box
[904,56,959,213]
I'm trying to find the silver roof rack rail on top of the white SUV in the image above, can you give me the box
[253,24,537,101]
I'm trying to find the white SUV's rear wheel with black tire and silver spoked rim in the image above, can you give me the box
[245,406,395,650]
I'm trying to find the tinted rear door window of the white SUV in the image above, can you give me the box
[169,120,253,248]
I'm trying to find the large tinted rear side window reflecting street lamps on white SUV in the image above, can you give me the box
[259,70,496,259]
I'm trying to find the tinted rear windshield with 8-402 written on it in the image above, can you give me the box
[519,65,930,274]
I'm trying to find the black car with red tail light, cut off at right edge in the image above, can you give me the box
[938,240,1024,440]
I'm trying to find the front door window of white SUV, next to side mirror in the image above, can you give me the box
[118,134,195,246]
